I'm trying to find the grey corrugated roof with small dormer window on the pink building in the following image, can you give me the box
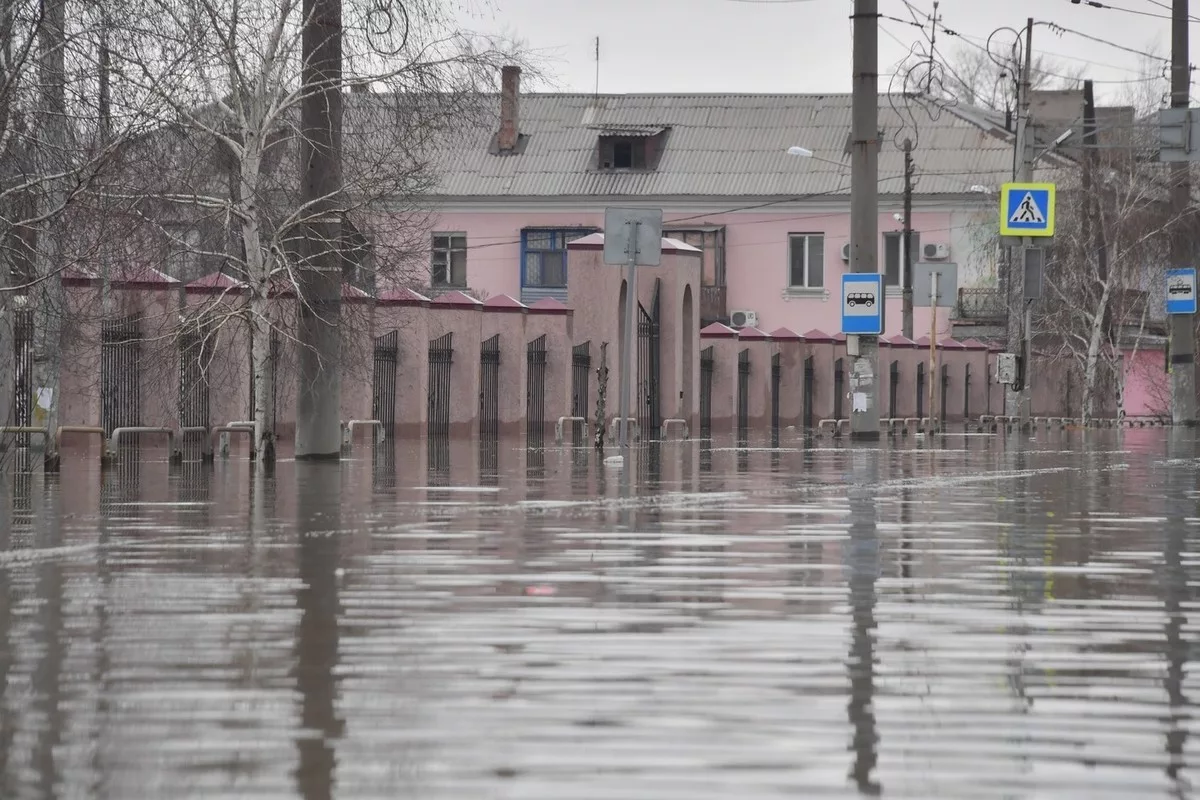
[434,94,1032,198]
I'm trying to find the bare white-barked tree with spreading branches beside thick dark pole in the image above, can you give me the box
[104,0,530,462]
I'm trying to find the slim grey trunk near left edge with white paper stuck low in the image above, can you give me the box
[34,0,67,469]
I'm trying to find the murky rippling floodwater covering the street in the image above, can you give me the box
[0,429,1200,800]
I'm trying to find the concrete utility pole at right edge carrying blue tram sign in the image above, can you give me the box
[1170,0,1196,426]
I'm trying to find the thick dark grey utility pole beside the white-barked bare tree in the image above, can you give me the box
[295,0,342,459]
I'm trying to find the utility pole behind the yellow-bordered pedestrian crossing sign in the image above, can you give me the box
[1004,17,1033,428]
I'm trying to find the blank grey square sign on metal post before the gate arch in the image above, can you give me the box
[604,207,662,449]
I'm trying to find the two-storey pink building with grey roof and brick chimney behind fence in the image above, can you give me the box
[417,70,1013,336]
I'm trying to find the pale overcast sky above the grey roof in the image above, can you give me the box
[458,0,1200,101]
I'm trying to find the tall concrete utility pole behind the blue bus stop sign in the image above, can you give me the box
[846,0,887,441]
